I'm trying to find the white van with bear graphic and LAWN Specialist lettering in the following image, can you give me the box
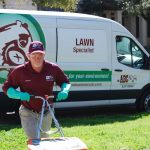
[0,9,150,111]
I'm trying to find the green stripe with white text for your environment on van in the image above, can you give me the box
[65,71,112,82]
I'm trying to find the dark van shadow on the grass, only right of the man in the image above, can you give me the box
[58,106,149,127]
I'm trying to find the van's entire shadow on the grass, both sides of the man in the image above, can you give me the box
[0,106,149,130]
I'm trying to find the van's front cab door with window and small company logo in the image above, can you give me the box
[111,32,149,104]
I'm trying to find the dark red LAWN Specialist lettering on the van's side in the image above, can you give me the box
[73,38,94,53]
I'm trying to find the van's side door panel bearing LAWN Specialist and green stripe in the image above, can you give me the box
[57,19,111,107]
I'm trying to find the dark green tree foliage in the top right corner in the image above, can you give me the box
[122,0,150,20]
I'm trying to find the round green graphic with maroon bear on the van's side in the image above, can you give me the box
[0,13,45,66]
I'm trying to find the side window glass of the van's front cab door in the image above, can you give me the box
[116,36,144,69]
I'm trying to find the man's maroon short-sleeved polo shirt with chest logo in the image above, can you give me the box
[2,61,69,112]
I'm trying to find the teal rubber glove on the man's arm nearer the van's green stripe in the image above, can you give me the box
[56,83,71,101]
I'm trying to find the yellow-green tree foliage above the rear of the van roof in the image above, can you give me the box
[32,0,78,11]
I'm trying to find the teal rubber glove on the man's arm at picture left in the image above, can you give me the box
[7,87,30,102]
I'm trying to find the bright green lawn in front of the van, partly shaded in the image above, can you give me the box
[0,108,150,150]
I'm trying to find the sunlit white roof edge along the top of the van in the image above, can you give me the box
[0,9,129,33]
